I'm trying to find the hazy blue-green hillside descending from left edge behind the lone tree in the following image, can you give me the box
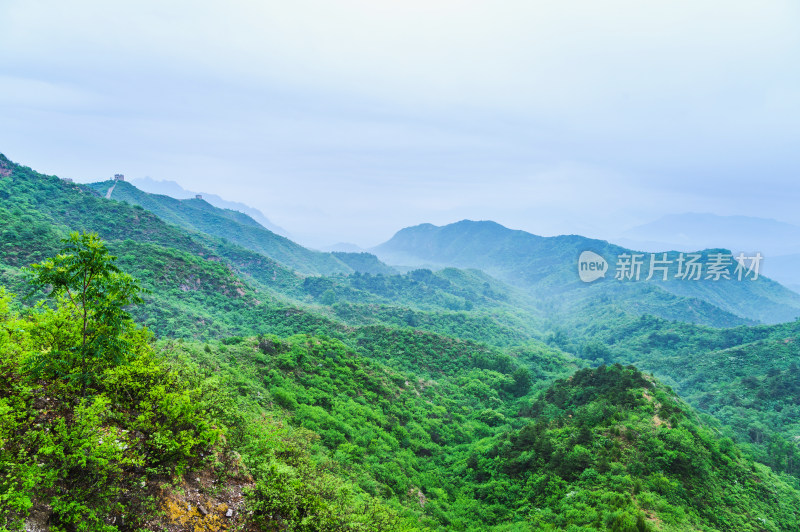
[0,153,535,345]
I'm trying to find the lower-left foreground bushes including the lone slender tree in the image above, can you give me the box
[0,242,397,531]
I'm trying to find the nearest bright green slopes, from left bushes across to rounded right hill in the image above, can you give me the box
[15,246,800,531]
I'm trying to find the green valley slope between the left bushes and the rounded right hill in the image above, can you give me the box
[167,329,568,529]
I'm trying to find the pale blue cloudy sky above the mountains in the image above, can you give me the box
[0,0,800,247]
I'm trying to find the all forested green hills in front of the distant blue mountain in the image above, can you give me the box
[0,152,800,531]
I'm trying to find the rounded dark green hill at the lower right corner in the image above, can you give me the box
[488,366,800,530]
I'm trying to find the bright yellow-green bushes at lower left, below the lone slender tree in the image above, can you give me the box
[0,291,220,530]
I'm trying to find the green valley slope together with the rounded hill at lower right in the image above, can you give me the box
[163,338,800,530]
